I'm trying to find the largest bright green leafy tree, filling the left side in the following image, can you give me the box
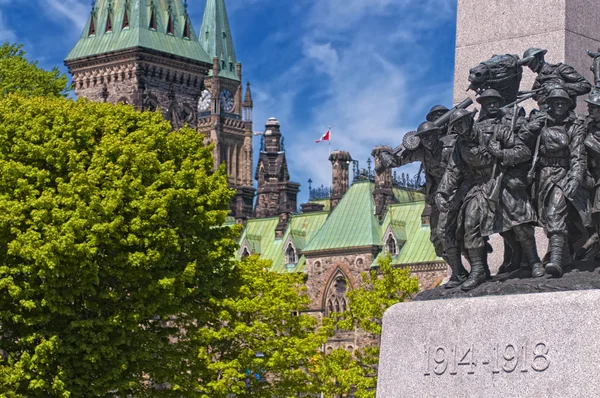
[0,95,239,397]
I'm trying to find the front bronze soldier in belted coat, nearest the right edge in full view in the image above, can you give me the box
[524,89,591,277]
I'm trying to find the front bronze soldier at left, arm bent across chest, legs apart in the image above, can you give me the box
[436,110,542,291]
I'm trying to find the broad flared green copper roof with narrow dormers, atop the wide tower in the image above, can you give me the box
[66,0,212,64]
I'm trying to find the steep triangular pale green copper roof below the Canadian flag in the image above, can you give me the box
[305,181,382,252]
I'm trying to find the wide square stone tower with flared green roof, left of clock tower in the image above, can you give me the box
[65,0,212,128]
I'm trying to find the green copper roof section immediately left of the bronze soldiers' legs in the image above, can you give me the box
[373,201,443,265]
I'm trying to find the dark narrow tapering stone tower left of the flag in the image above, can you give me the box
[255,118,300,225]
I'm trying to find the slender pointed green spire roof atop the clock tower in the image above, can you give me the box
[200,0,240,81]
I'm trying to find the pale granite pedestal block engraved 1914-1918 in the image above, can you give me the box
[377,290,600,398]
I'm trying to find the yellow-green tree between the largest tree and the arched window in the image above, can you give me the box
[192,256,329,398]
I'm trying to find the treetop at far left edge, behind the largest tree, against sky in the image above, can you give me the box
[0,43,68,97]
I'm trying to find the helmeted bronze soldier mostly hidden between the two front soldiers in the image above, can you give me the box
[475,89,540,273]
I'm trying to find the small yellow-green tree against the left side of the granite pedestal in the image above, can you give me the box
[316,255,419,398]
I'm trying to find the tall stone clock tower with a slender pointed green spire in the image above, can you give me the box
[197,0,255,221]
